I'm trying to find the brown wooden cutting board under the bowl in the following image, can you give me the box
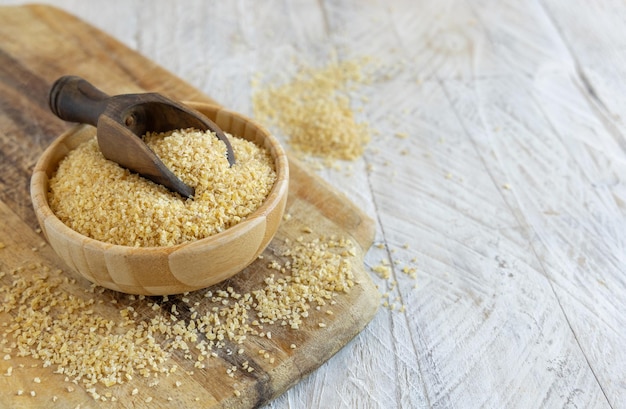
[0,6,380,408]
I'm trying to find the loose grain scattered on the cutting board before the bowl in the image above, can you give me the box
[0,217,355,401]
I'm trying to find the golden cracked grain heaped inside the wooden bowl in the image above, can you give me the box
[49,129,276,247]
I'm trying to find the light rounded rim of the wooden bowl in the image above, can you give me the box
[30,101,289,255]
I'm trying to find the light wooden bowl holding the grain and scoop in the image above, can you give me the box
[30,103,289,295]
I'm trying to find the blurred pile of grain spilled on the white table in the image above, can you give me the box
[253,59,370,160]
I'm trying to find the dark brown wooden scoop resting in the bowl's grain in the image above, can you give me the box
[49,76,235,197]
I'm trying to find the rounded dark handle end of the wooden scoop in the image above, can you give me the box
[48,75,109,126]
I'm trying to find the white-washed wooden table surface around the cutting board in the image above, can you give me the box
[0,0,626,409]
